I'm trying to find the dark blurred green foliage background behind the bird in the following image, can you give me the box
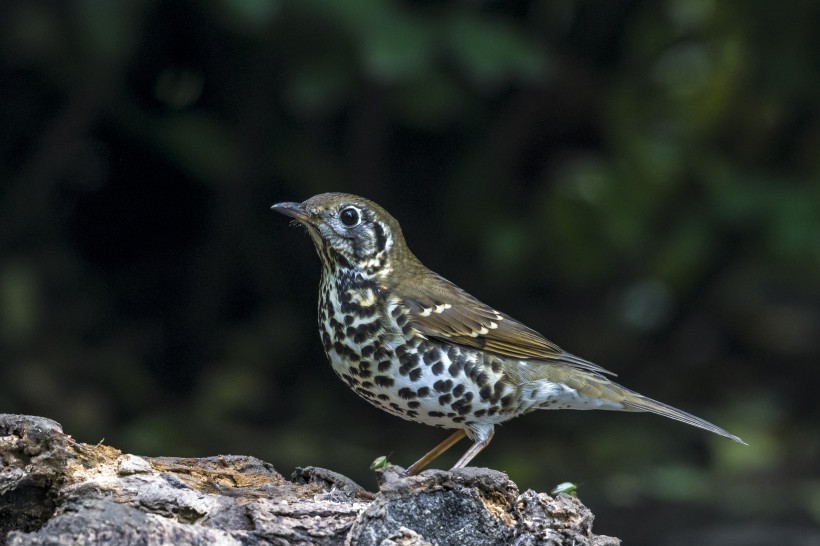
[0,0,820,546]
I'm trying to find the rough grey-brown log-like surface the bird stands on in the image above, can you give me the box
[0,415,620,546]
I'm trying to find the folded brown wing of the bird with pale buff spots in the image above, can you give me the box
[397,273,615,375]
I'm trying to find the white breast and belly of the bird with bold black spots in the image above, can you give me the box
[319,274,532,429]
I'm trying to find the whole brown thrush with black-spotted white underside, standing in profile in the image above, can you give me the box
[271,193,745,476]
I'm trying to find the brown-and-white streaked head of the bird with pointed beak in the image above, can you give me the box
[271,193,409,277]
